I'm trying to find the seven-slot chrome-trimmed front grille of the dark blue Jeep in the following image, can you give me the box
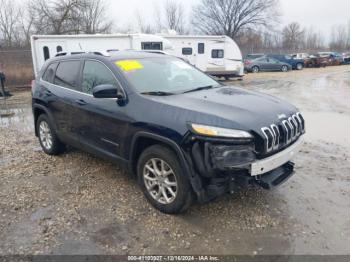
[261,112,305,153]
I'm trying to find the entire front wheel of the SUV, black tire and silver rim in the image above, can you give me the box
[137,145,192,214]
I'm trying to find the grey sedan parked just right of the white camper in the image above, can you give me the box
[244,56,292,73]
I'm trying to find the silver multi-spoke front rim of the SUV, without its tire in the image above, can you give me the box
[143,158,178,204]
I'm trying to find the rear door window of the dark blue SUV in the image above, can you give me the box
[54,61,80,91]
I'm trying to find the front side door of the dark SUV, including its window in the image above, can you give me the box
[77,60,126,156]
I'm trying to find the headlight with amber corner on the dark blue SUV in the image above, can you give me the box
[190,124,253,138]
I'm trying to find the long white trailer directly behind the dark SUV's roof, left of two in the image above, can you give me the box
[31,34,172,75]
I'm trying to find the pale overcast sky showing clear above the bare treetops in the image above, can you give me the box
[109,0,350,36]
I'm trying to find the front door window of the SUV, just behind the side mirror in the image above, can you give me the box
[82,61,118,94]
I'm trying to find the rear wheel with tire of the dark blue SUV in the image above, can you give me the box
[36,114,65,155]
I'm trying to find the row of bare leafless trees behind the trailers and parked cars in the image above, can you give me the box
[0,0,350,53]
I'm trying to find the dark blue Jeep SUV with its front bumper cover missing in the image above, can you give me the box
[32,51,305,213]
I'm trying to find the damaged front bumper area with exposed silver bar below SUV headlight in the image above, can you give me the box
[187,137,302,202]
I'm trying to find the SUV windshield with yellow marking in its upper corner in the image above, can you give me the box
[115,57,220,94]
